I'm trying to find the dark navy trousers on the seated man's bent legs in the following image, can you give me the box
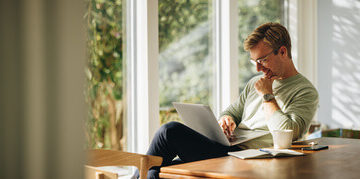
[141,122,241,178]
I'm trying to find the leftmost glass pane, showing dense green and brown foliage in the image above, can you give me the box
[85,0,126,150]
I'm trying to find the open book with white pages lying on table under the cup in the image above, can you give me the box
[228,149,305,159]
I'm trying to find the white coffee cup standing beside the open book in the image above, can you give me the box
[271,129,293,149]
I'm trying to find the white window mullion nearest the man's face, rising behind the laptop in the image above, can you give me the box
[214,0,239,116]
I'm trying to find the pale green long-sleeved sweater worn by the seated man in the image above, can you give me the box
[220,74,319,148]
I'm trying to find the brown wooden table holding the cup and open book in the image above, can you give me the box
[160,137,360,179]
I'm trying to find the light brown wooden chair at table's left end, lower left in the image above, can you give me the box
[85,149,162,179]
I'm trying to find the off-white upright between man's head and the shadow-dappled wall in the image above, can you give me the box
[287,0,317,86]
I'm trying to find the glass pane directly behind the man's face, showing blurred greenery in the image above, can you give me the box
[238,0,284,92]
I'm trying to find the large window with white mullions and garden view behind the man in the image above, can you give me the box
[86,0,284,152]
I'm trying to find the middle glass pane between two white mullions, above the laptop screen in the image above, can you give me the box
[159,0,214,124]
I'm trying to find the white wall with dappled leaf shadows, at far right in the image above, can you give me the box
[317,0,360,129]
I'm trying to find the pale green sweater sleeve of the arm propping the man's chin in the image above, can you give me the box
[267,88,319,140]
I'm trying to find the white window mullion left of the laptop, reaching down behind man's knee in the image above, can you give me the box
[127,0,160,153]
